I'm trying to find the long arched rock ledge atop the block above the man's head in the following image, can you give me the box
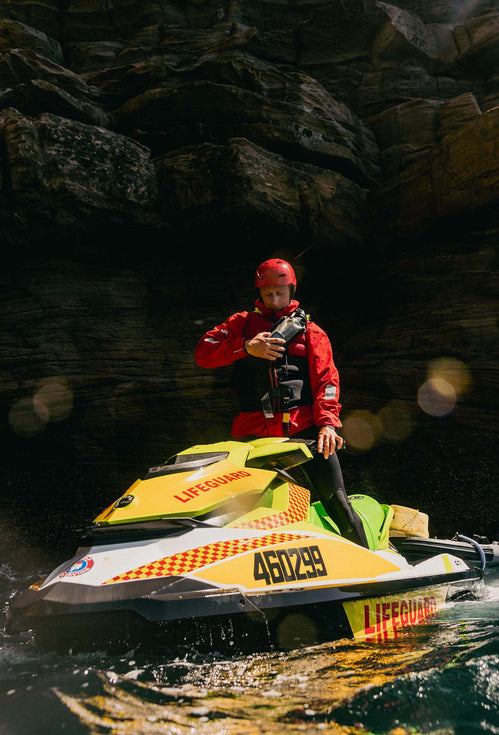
[113,69,378,183]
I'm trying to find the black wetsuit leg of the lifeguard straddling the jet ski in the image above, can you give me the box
[293,426,369,548]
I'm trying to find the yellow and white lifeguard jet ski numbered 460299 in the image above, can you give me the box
[7,438,483,650]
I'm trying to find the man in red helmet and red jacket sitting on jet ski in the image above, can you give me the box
[195,258,368,546]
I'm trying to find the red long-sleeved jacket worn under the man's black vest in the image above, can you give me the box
[195,300,341,439]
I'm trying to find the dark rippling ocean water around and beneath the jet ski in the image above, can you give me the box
[0,526,499,735]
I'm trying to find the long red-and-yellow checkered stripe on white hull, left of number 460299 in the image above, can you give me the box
[103,533,303,584]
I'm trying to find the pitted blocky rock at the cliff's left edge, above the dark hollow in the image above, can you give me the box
[0,109,156,224]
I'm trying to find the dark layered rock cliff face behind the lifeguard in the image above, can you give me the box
[0,0,499,536]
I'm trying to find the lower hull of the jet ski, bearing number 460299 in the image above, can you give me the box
[8,529,481,650]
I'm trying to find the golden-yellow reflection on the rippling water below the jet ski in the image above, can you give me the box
[44,626,484,735]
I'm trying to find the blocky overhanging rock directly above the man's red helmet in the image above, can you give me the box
[157,139,368,248]
